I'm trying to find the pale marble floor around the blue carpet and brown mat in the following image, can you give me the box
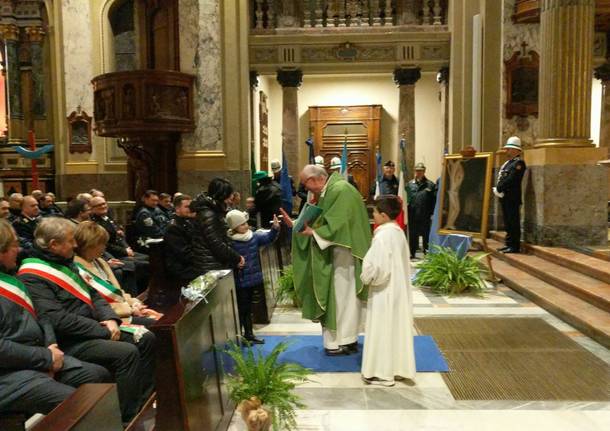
[229,258,610,431]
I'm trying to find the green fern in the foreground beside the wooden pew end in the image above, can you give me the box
[226,341,312,431]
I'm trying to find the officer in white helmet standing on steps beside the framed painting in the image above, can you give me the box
[493,136,526,253]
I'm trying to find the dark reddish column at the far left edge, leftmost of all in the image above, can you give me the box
[0,24,25,142]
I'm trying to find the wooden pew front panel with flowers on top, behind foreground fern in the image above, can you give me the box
[151,274,239,431]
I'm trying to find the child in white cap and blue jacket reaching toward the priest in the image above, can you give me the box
[226,210,280,344]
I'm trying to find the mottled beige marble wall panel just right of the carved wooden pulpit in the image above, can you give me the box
[178,0,223,152]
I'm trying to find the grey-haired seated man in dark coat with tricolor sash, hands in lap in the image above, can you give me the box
[18,217,155,422]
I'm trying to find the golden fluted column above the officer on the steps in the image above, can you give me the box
[535,0,595,148]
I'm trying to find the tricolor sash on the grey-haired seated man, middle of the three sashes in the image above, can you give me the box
[18,258,93,307]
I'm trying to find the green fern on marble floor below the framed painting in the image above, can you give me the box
[413,245,487,295]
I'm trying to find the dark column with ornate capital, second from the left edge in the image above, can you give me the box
[25,27,47,141]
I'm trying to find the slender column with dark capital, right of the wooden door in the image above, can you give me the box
[394,67,421,177]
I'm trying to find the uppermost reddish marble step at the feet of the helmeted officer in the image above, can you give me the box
[488,231,610,284]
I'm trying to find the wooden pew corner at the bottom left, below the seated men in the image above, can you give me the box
[32,383,123,431]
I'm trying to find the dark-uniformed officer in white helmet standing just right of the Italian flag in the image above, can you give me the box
[407,163,436,259]
